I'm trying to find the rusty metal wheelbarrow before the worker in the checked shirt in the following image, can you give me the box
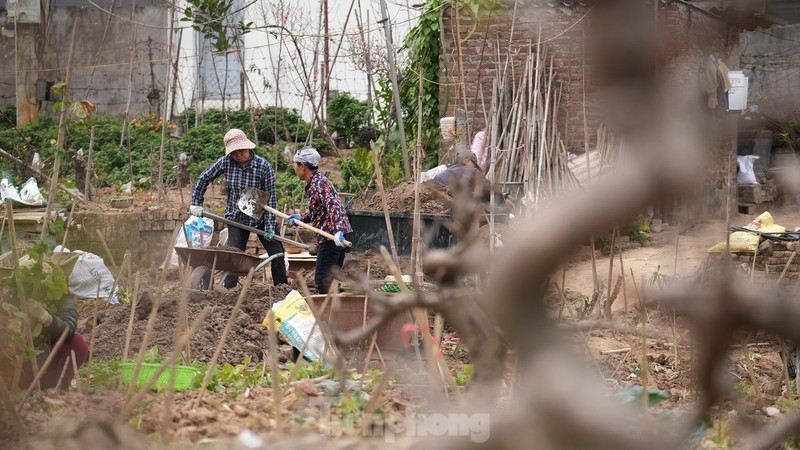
[175,247,283,290]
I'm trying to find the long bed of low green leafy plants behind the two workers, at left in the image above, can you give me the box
[0,105,318,192]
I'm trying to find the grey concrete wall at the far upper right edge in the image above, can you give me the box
[740,25,800,117]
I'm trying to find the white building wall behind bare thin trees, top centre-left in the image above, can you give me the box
[175,0,419,120]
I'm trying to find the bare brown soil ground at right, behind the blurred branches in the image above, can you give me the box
[551,205,800,415]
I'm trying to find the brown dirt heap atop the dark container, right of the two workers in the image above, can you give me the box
[353,180,453,214]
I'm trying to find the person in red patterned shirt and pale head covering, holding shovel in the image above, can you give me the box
[289,147,353,294]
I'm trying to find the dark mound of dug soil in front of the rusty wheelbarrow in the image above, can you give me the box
[87,280,296,364]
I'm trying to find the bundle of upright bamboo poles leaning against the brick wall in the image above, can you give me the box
[487,45,619,208]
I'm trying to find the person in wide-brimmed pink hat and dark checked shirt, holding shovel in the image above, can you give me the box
[189,128,288,288]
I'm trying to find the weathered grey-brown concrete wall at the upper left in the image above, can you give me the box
[0,0,168,116]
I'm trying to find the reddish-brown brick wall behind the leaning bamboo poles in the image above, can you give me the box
[440,2,739,216]
